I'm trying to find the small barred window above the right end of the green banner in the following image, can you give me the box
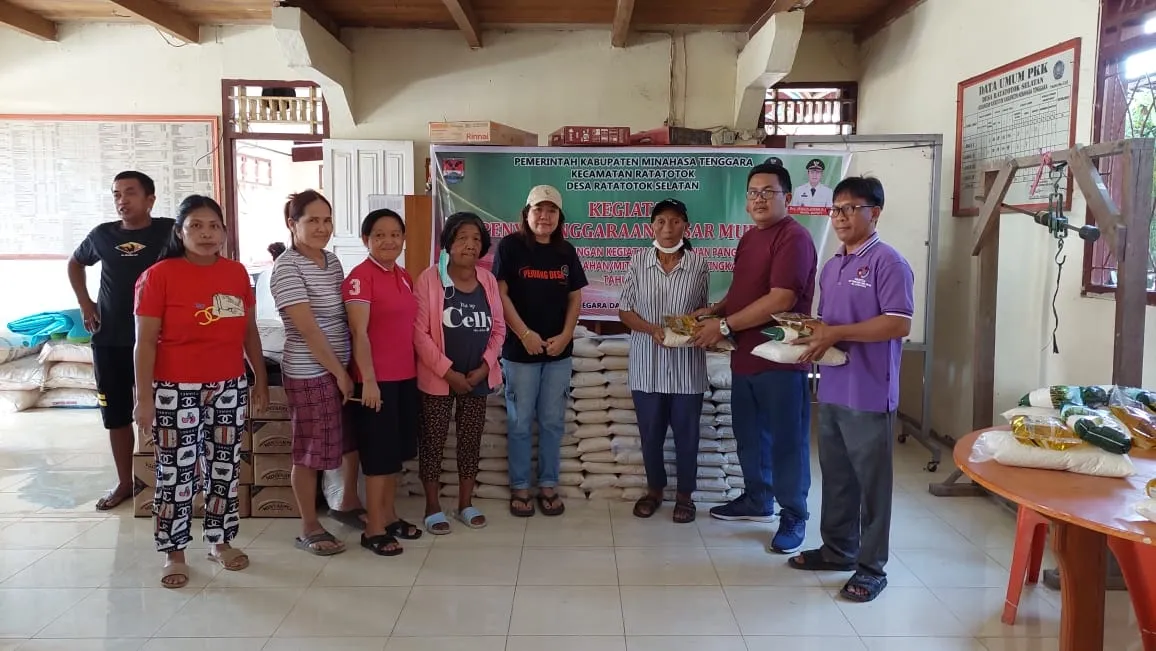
[759,83,858,146]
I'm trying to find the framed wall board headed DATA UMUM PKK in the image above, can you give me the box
[951,38,1080,217]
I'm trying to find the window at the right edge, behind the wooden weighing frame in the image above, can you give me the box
[1083,0,1156,304]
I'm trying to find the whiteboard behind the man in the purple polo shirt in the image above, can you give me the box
[787,135,942,345]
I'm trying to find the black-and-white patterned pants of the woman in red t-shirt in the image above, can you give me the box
[153,377,249,552]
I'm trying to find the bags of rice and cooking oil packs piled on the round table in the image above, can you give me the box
[971,385,1156,476]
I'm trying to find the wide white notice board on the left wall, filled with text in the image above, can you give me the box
[0,114,221,259]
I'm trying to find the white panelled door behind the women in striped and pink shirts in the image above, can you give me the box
[321,140,414,274]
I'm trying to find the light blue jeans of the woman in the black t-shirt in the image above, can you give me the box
[502,357,573,490]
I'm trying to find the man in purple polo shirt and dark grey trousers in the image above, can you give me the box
[790,177,914,602]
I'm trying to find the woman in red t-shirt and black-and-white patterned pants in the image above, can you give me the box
[134,194,268,587]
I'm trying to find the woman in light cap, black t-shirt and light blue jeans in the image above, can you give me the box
[494,185,587,517]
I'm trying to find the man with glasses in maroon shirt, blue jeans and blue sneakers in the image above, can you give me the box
[696,163,817,554]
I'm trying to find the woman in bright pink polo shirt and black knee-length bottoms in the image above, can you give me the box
[341,208,422,556]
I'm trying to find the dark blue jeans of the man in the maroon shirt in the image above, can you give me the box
[731,371,810,520]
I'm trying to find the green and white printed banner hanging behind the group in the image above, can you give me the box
[431,146,850,319]
